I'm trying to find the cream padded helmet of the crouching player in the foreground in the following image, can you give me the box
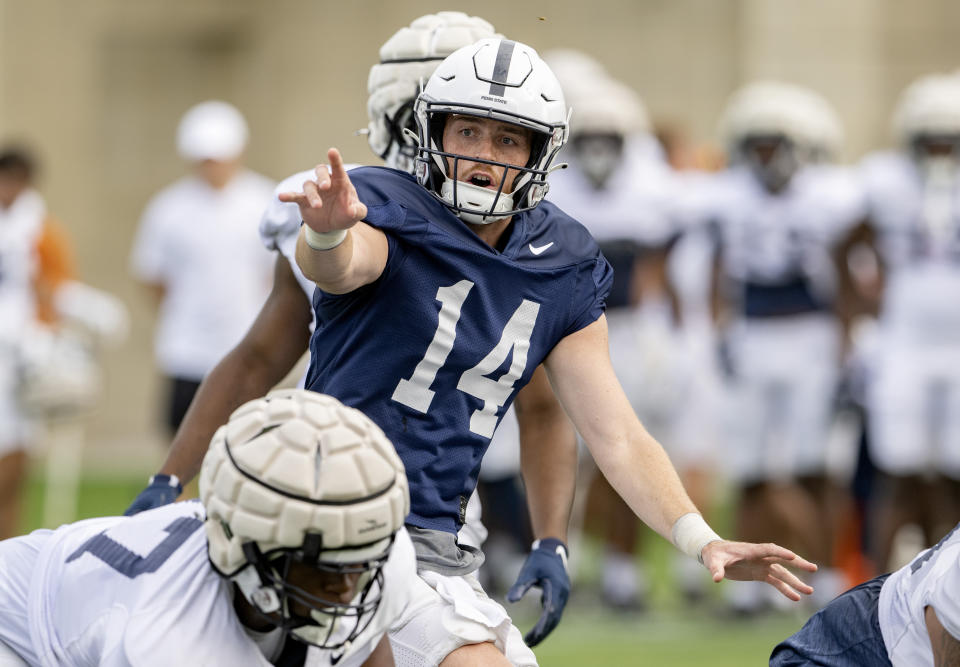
[200,390,410,648]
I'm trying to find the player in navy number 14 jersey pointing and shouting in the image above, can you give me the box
[280,39,816,665]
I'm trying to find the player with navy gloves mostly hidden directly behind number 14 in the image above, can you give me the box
[127,12,576,644]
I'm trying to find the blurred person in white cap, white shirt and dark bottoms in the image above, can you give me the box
[131,101,274,434]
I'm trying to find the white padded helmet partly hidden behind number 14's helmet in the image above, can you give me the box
[367,12,496,173]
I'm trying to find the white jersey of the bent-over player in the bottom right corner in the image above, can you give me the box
[878,526,960,667]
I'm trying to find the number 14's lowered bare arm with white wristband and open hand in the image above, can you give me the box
[545,317,816,600]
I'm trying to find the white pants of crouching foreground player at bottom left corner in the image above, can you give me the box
[0,530,53,667]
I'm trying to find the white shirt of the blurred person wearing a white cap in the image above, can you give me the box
[131,171,273,380]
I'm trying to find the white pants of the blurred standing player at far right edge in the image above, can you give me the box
[867,338,960,479]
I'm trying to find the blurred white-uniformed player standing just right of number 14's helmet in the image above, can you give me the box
[546,50,707,609]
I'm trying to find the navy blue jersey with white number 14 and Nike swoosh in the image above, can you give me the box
[306,167,612,532]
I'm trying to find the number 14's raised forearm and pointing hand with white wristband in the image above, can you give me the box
[280,148,387,294]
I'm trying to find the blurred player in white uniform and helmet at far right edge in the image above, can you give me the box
[846,75,960,571]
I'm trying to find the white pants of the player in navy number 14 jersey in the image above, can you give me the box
[390,571,537,667]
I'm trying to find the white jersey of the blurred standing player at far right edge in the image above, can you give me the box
[861,153,960,343]
